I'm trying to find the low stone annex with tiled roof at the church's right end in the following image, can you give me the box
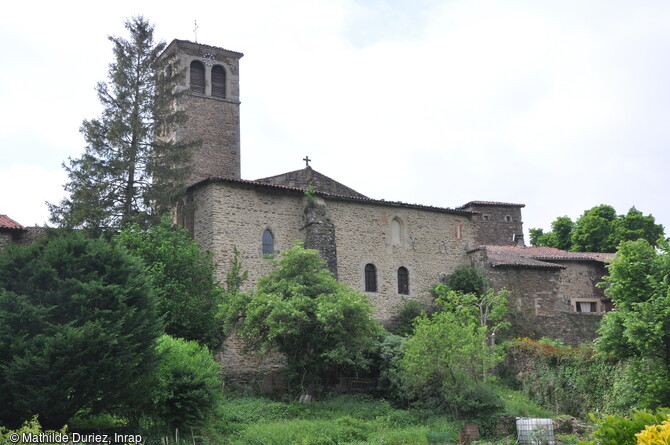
[468,245,614,345]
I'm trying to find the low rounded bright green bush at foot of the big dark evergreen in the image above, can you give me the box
[146,335,223,430]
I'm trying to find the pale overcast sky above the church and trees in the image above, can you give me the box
[0,0,670,239]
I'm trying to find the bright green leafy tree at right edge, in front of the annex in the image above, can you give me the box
[597,239,670,408]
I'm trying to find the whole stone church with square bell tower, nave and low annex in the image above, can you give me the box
[164,40,611,365]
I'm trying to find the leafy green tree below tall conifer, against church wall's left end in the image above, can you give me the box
[117,218,223,349]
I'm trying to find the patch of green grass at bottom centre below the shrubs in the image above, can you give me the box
[214,396,461,445]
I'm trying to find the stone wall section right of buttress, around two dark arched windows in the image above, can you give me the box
[326,199,474,322]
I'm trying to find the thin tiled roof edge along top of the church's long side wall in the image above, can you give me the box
[187,177,478,216]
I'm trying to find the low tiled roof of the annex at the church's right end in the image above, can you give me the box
[470,246,614,269]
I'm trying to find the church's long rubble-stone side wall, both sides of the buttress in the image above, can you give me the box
[187,182,474,381]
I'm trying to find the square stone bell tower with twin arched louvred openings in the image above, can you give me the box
[162,40,243,185]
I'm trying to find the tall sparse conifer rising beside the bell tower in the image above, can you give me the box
[49,17,192,234]
